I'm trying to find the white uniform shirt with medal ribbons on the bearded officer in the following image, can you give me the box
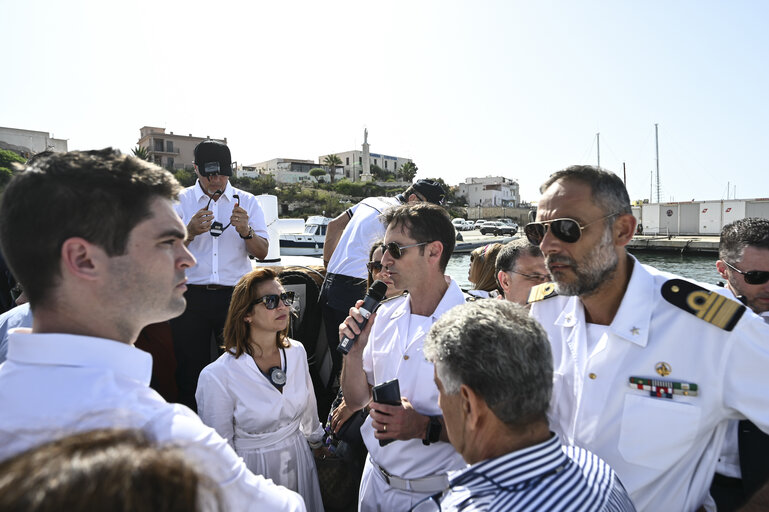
[531,259,769,511]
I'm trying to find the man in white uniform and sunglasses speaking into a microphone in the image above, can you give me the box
[339,203,465,511]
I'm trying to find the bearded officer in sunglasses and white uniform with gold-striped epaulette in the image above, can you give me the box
[524,166,769,512]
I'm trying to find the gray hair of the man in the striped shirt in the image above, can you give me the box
[424,300,553,427]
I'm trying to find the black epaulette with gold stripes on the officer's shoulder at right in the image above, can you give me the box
[662,279,746,331]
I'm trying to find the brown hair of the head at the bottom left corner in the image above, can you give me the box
[0,429,223,512]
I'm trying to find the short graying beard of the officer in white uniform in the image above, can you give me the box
[545,227,619,296]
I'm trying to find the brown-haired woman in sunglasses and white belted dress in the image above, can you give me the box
[195,268,323,511]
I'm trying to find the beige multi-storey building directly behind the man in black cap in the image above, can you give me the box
[137,126,225,170]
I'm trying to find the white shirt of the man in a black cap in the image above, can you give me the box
[174,181,270,286]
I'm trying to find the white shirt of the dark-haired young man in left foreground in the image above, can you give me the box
[0,329,305,511]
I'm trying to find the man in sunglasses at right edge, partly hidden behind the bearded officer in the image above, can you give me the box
[710,217,769,511]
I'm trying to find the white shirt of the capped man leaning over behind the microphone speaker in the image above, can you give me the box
[328,197,401,279]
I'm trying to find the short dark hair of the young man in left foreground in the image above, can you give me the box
[0,148,182,309]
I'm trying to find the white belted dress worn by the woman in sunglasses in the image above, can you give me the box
[195,340,323,512]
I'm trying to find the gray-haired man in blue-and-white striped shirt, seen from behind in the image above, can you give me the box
[414,301,635,512]
